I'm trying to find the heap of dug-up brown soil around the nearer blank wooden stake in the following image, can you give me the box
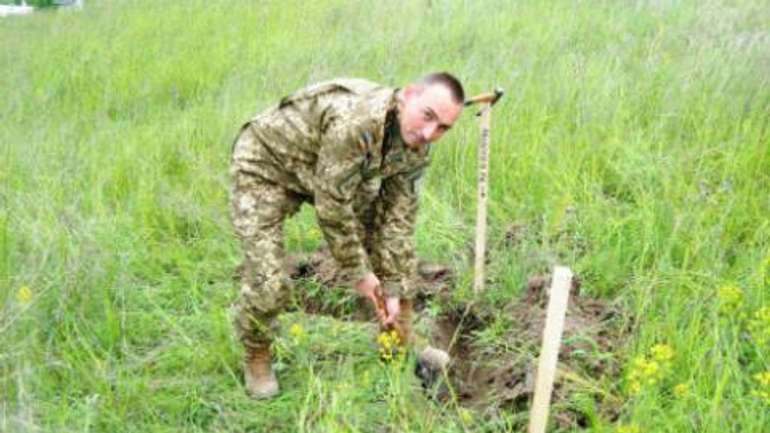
[434,276,628,429]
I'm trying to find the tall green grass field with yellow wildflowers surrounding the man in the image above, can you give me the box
[0,0,770,433]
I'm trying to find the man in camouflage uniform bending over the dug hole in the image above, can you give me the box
[225,73,464,398]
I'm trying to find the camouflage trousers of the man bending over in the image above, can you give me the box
[230,140,378,348]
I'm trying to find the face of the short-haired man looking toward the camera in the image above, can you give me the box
[398,83,463,148]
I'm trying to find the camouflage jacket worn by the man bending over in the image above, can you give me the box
[233,79,430,296]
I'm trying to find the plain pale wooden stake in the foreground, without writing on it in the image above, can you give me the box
[529,266,572,433]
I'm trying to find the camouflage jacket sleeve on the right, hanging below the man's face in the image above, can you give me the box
[372,168,424,298]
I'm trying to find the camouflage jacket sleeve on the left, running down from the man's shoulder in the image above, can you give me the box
[315,115,373,287]
